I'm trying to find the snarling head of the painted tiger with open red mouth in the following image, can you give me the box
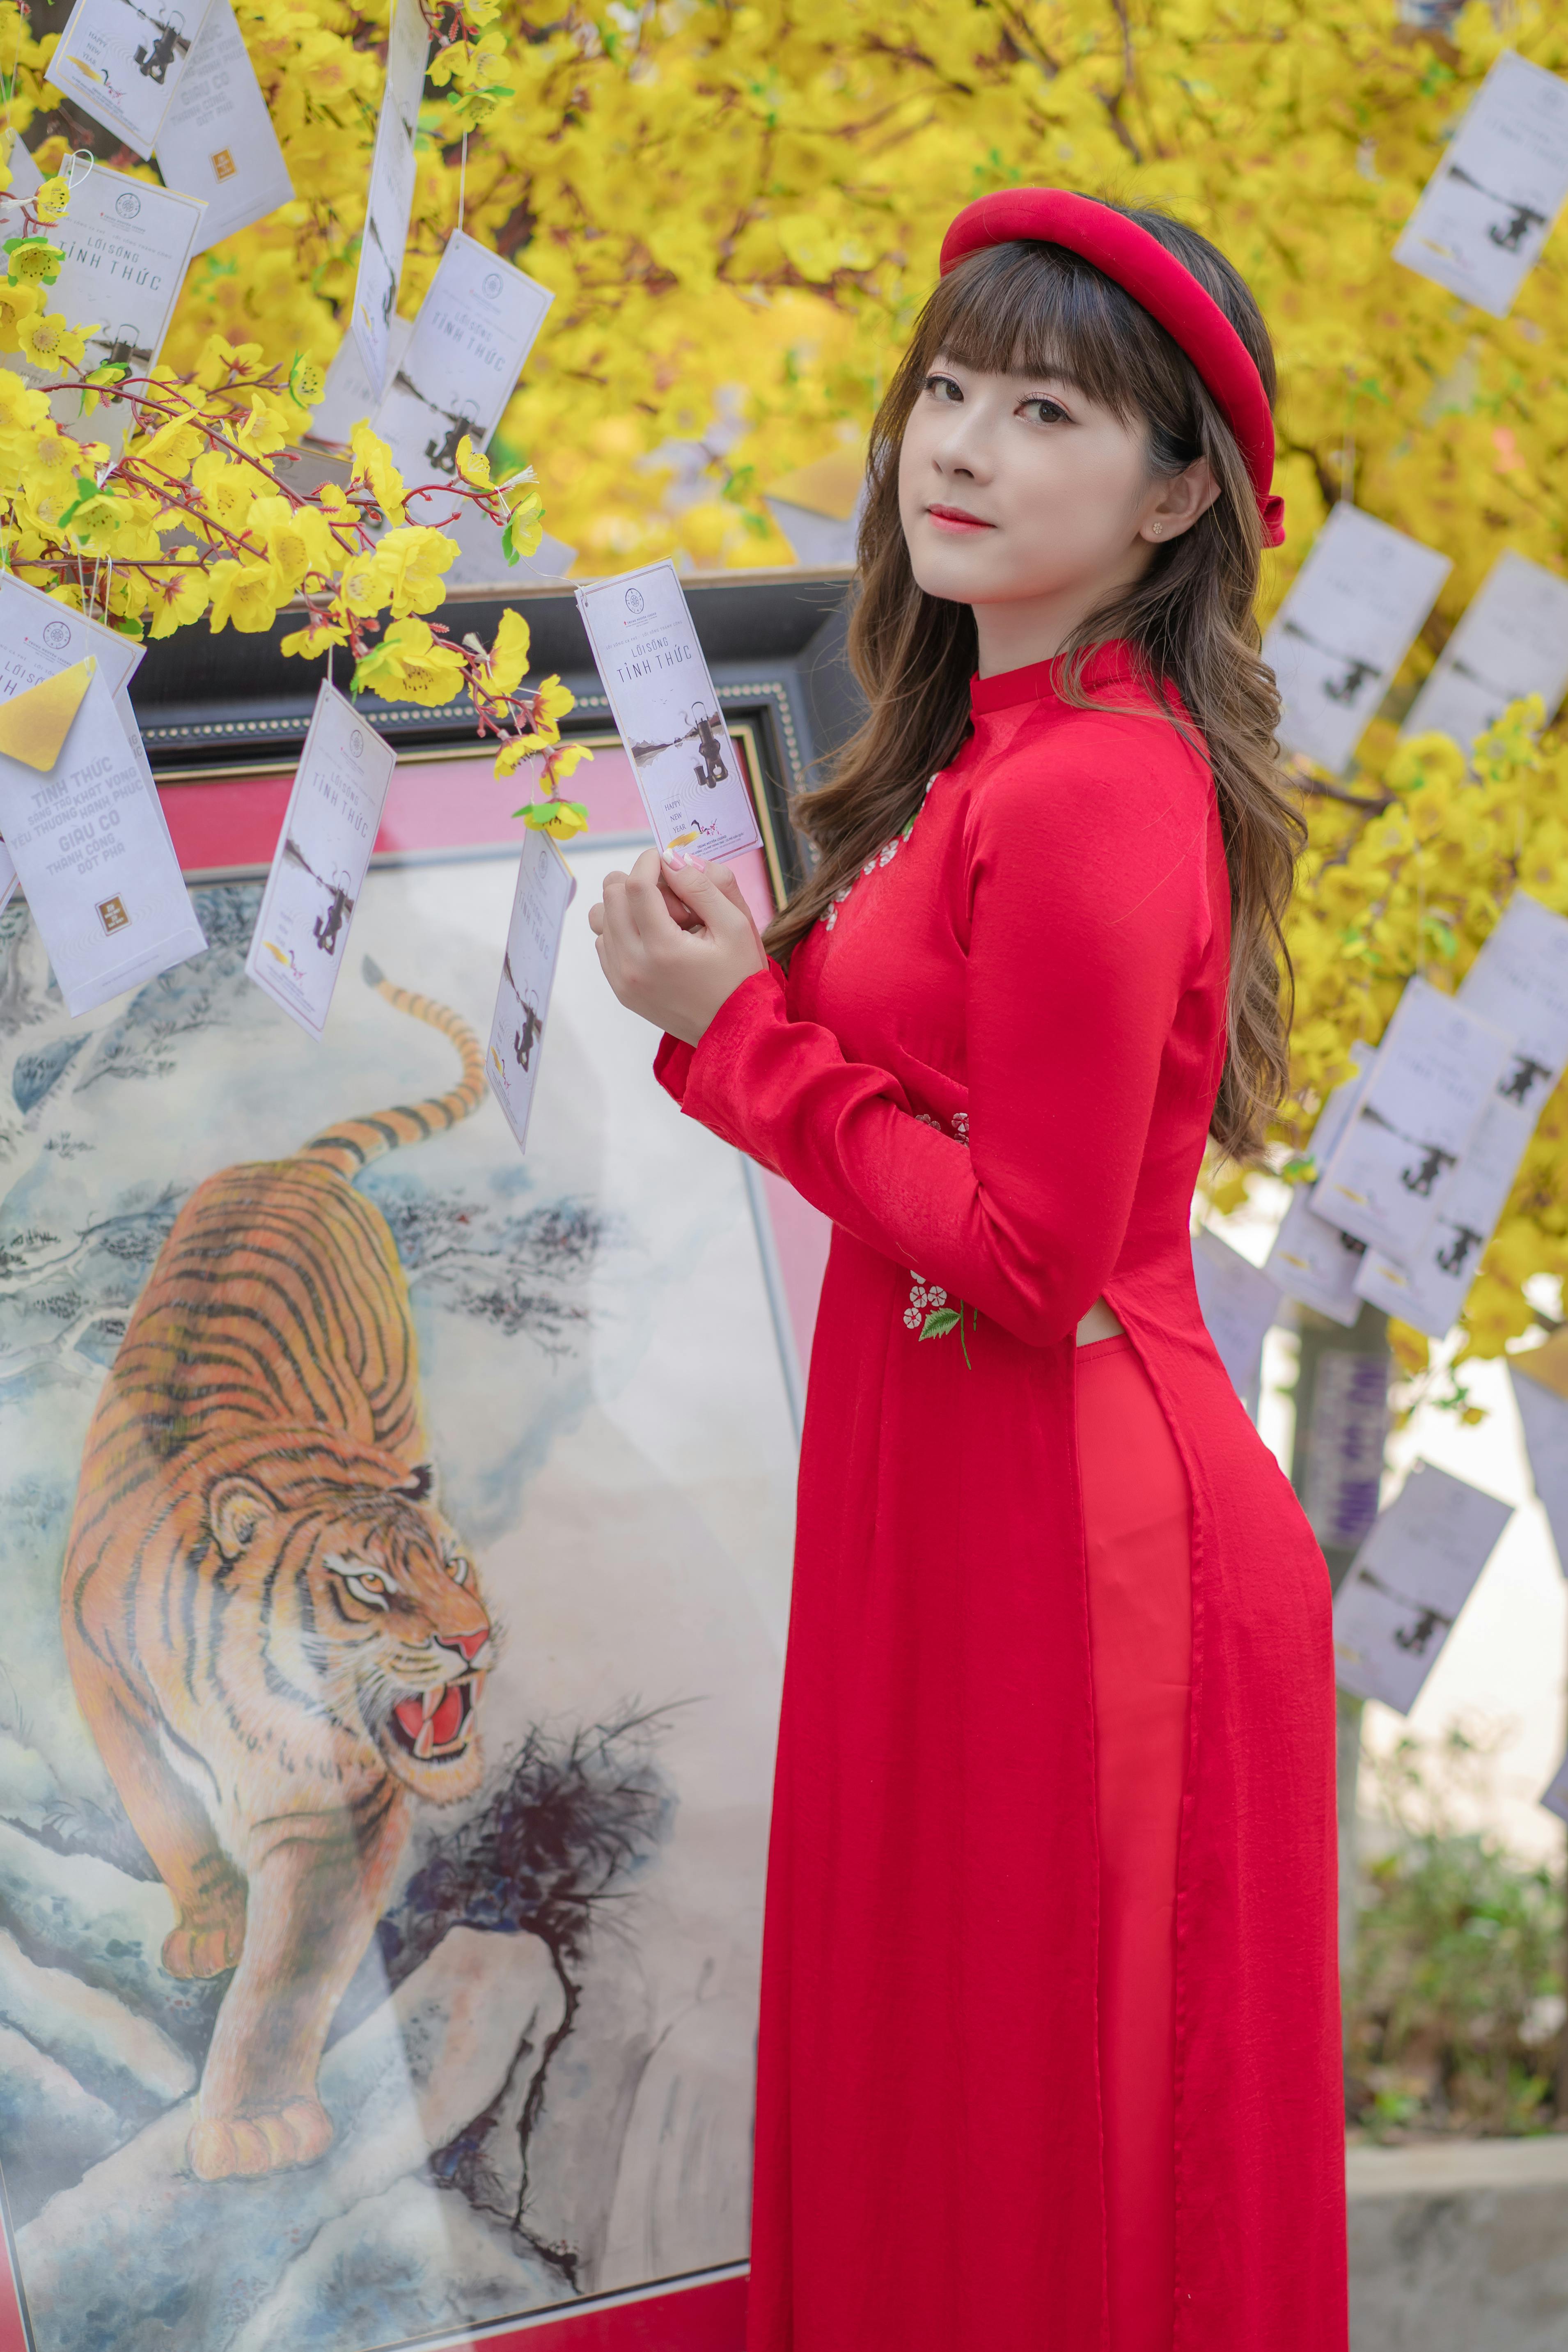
[204,1453,496,1804]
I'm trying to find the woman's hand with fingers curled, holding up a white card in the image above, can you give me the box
[588,849,769,1044]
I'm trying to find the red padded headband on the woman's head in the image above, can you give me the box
[943,188,1286,548]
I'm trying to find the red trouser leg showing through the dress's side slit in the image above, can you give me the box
[1077,1338,1192,2352]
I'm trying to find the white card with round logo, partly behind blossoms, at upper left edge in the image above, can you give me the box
[23,162,202,449]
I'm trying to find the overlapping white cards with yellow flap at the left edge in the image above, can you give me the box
[0,576,207,1014]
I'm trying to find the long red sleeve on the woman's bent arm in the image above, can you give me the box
[658,713,1218,1346]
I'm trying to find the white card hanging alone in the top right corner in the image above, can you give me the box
[1394,49,1568,318]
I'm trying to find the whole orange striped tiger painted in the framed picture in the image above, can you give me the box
[61,960,494,2180]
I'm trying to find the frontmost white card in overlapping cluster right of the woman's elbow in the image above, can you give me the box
[1312,981,1512,1268]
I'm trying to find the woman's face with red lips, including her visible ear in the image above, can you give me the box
[898,355,1218,670]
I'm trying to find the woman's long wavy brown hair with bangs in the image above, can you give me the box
[766,207,1305,1157]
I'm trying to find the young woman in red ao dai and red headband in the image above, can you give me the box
[592,188,1345,2352]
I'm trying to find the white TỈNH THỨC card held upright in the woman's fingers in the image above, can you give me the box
[576,562,762,858]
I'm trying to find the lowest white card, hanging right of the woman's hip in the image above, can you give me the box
[1333,1463,1514,1715]
